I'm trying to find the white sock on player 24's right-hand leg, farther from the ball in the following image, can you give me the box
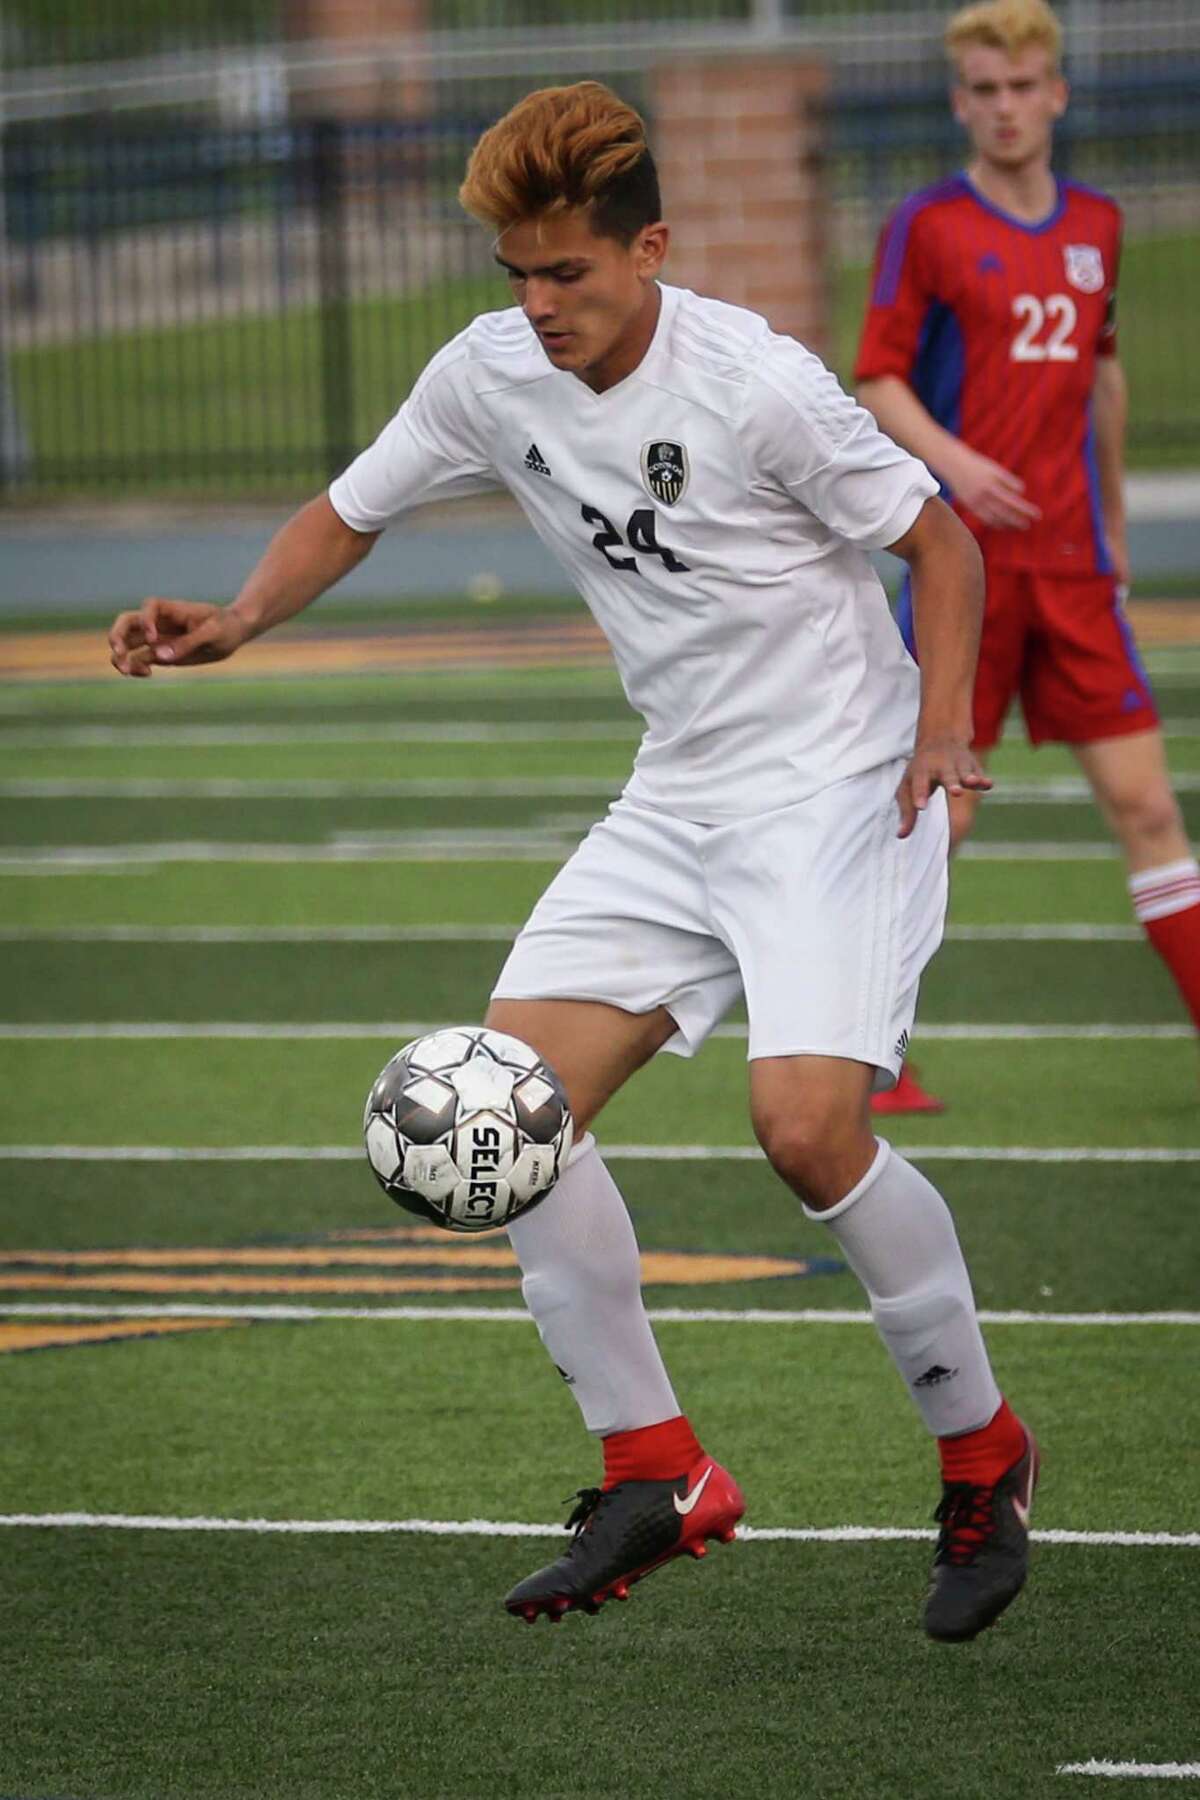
[804,1141,1000,1438]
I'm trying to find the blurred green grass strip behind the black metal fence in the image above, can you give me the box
[13,234,1200,495]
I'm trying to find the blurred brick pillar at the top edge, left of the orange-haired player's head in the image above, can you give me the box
[284,0,428,119]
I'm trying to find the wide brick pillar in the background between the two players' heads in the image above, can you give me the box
[649,56,829,353]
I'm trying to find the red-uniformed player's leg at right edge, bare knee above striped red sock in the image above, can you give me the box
[1072,731,1200,1030]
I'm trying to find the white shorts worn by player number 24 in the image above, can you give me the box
[493,761,950,1089]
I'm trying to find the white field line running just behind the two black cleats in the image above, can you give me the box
[0,1512,1200,1550]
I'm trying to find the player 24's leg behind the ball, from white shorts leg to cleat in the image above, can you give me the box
[488,808,743,1622]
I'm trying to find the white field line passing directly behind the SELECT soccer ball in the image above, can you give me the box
[0,1143,1200,1165]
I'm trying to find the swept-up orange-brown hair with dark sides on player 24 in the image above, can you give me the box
[459,81,662,245]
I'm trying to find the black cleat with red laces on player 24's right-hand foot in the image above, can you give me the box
[925,1431,1038,1643]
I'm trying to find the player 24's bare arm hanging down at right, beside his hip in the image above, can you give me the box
[887,499,991,837]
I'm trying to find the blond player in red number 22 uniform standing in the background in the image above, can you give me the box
[855,0,1200,1100]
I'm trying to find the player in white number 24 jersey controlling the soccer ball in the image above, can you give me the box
[110,83,1036,1640]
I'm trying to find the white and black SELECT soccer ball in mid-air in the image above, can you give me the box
[363,1026,574,1231]
